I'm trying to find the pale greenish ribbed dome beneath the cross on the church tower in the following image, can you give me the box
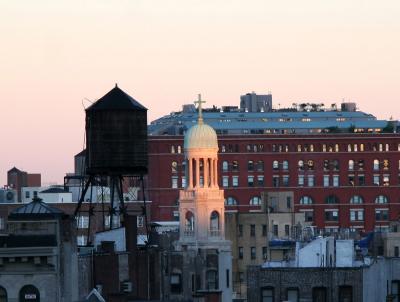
[184,123,218,149]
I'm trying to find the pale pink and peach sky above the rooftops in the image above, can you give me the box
[0,0,400,186]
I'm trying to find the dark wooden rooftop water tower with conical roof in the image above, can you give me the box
[75,85,148,243]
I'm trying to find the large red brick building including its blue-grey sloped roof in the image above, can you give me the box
[148,95,400,232]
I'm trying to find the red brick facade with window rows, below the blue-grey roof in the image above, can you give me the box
[148,133,400,232]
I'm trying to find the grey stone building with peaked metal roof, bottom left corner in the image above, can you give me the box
[0,199,78,302]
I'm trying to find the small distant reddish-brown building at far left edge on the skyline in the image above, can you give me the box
[7,167,42,202]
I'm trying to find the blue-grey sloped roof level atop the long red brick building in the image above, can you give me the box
[148,95,398,135]
